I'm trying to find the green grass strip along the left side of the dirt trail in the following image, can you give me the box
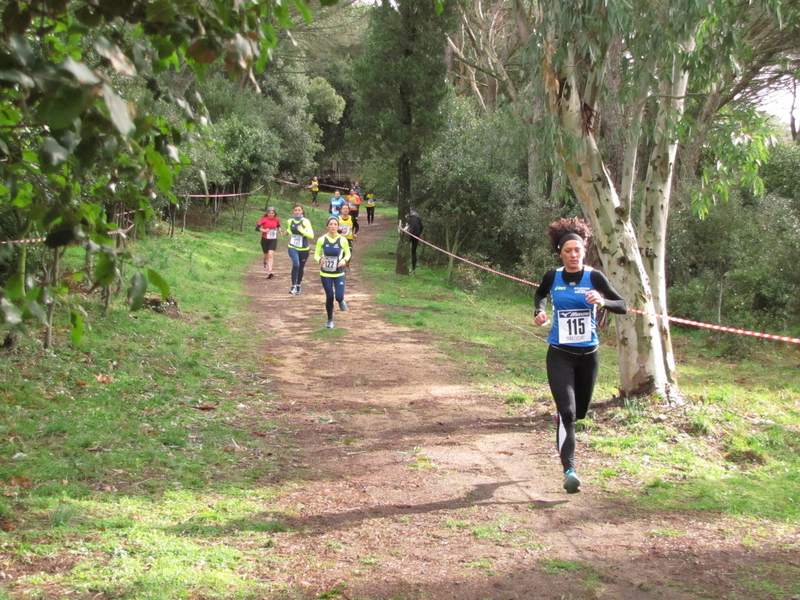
[0,200,291,600]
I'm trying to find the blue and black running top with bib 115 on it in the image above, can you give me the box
[534,267,628,348]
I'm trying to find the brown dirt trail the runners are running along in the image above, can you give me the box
[246,217,788,600]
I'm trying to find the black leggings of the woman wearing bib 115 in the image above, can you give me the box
[547,345,600,471]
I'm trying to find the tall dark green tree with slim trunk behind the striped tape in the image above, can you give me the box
[354,0,448,275]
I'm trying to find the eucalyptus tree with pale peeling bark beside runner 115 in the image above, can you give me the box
[514,0,786,394]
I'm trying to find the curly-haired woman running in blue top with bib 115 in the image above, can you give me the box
[534,218,628,494]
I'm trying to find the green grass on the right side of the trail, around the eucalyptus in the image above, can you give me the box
[365,225,800,523]
